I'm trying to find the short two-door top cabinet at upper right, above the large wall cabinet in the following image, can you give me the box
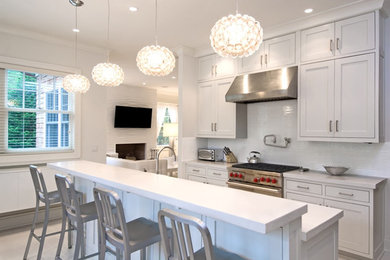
[301,13,375,62]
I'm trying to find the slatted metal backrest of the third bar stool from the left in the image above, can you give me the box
[93,188,129,248]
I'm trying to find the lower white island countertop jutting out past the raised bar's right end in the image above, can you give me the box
[301,204,344,241]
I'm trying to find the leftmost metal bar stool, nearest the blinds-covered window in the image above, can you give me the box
[23,165,72,260]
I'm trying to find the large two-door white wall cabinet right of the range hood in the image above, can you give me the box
[298,54,379,142]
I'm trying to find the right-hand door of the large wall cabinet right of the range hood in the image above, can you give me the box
[335,54,375,138]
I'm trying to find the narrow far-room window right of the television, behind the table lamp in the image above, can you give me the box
[157,103,177,145]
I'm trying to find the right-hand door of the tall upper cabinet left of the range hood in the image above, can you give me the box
[213,78,236,138]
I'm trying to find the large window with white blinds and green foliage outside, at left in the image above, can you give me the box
[0,69,74,153]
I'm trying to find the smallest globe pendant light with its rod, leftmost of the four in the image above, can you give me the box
[62,1,91,93]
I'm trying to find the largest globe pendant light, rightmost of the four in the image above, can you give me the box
[210,0,263,58]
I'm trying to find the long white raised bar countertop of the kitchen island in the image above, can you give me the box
[48,160,307,234]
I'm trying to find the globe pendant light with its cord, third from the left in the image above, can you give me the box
[137,0,176,76]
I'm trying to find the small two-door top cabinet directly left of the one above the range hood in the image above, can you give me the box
[198,54,237,81]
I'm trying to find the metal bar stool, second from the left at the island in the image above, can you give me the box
[55,174,99,260]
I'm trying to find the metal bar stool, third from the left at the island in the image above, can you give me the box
[93,188,161,260]
